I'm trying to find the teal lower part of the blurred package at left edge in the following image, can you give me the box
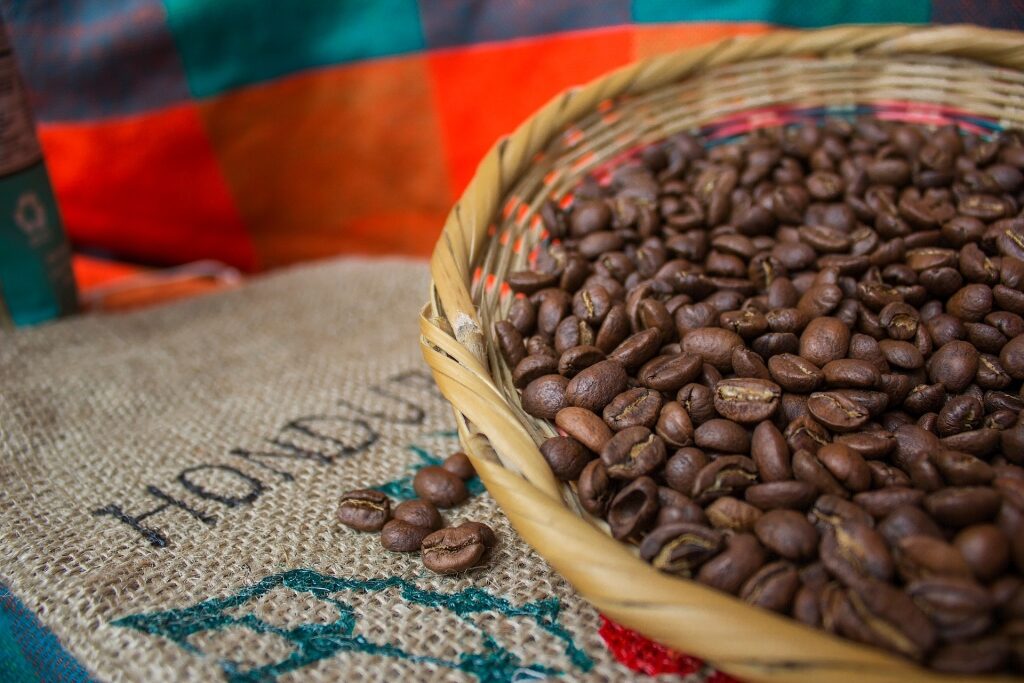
[0,163,76,325]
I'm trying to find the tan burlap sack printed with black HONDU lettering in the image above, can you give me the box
[0,261,708,682]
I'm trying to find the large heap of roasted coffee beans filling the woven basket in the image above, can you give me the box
[494,119,1024,673]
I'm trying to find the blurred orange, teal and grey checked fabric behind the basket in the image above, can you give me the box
[0,0,1024,290]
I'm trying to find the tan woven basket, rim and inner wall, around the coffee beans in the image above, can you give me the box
[421,27,1024,683]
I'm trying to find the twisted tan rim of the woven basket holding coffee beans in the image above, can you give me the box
[420,25,1024,683]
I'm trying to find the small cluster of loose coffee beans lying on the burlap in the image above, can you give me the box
[338,453,498,573]
